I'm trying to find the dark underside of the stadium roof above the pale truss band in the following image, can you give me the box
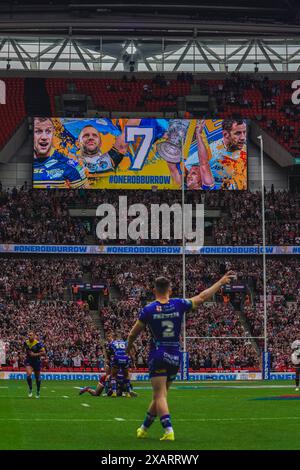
[0,0,300,37]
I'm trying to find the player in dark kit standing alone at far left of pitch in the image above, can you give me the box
[24,331,46,398]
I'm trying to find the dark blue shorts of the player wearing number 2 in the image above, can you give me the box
[148,348,180,382]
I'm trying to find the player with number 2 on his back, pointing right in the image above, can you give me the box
[127,271,236,441]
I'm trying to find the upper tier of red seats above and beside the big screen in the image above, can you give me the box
[0,74,300,156]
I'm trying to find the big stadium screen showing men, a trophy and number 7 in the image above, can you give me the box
[33,117,247,190]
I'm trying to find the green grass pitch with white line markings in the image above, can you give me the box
[0,380,300,450]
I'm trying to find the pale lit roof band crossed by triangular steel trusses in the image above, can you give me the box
[0,35,300,73]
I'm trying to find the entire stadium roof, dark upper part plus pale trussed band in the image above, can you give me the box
[0,0,300,72]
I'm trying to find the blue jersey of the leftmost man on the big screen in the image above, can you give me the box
[33,150,87,189]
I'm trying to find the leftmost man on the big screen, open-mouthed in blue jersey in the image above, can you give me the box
[33,118,87,189]
